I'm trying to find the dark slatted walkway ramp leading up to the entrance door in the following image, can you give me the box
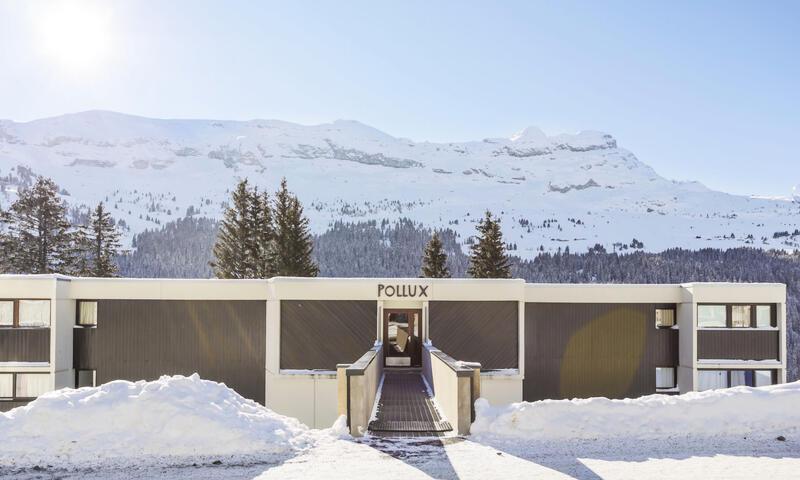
[369,368,453,437]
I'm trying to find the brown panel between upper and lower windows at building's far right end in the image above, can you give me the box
[697,329,779,360]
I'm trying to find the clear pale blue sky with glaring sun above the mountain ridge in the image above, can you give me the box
[0,0,800,195]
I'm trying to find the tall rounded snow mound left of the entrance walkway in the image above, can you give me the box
[0,374,308,465]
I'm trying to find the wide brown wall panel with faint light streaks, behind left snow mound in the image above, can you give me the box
[93,300,266,404]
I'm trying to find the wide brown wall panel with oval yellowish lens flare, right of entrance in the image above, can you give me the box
[523,303,678,401]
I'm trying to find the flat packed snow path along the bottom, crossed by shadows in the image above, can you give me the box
[0,436,800,480]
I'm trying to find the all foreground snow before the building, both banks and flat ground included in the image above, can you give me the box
[0,377,800,480]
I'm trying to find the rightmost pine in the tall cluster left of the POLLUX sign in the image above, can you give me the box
[272,178,319,277]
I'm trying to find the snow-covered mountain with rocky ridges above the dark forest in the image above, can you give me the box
[0,111,800,257]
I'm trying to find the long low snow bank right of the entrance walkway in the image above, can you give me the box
[471,382,800,440]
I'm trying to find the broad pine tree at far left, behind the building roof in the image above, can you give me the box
[6,177,74,273]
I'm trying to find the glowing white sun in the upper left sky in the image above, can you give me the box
[35,1,112,72]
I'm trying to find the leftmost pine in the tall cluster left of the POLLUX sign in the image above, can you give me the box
[211,179,255,278]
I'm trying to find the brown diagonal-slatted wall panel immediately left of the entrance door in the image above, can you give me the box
[281,300,378,370]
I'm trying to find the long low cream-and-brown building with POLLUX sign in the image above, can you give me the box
[0,275,787,433]
